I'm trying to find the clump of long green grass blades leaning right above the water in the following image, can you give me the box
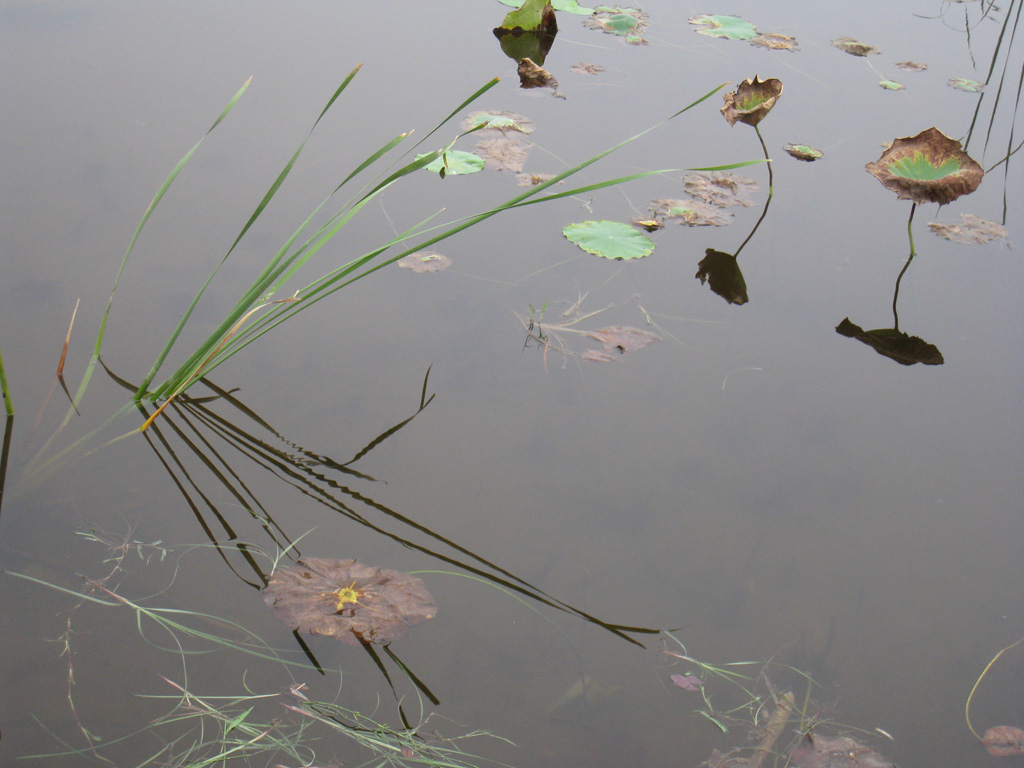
[30,67,724,471]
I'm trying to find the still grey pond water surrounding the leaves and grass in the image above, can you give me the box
[0,0,1024,768]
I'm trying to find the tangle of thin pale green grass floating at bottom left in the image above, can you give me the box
[8,531,510,768]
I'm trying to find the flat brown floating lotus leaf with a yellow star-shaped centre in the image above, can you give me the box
[263,557,437,645]
